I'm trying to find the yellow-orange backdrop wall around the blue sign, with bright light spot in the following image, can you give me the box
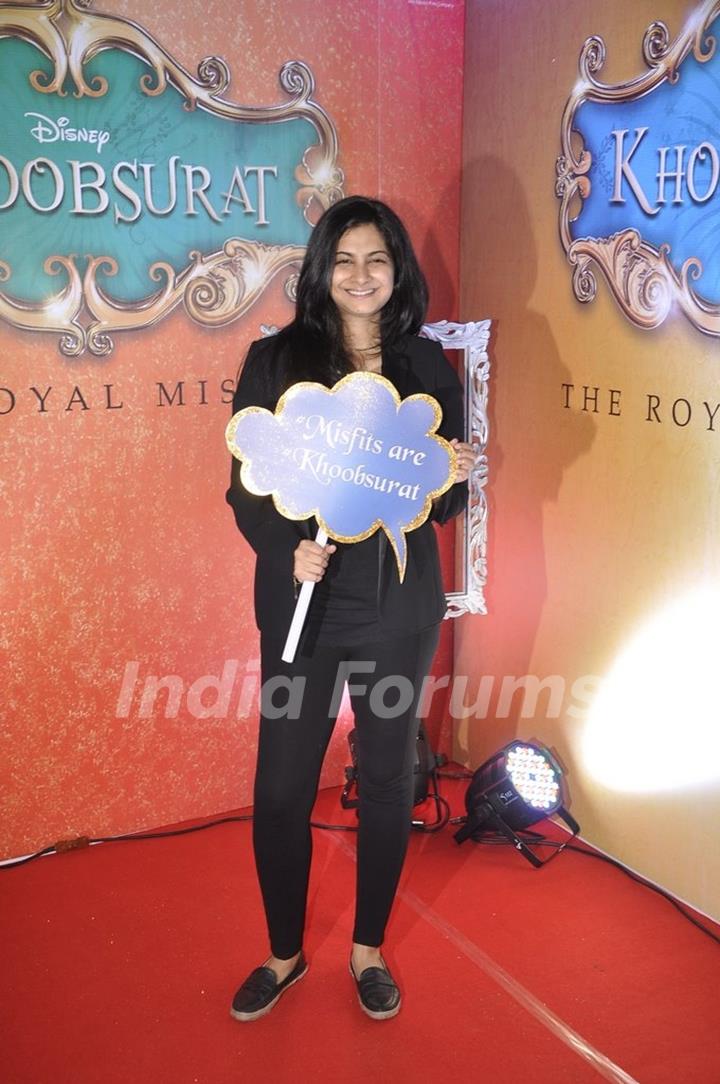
[455,0,720,916]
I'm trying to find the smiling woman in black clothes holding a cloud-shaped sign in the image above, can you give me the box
[228,196,475,1020]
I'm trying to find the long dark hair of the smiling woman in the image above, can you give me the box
[270,196,427,387]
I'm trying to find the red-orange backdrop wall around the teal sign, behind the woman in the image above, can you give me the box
[0,0,466,856]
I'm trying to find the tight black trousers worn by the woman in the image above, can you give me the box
[253,625,439,959]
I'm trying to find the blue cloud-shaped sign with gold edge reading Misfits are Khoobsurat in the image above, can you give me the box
[226,373,455,580]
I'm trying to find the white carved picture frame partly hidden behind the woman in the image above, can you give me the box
[422,320,491,617]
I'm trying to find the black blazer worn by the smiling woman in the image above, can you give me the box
[227,335,467,637]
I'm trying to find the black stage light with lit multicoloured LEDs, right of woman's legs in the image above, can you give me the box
[454,741,580,866]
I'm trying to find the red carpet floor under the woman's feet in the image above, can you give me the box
[0,782,720,1084]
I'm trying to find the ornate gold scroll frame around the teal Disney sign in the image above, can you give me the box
[0,0,344,357]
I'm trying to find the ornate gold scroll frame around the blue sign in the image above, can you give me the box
[555,0,720,335]
